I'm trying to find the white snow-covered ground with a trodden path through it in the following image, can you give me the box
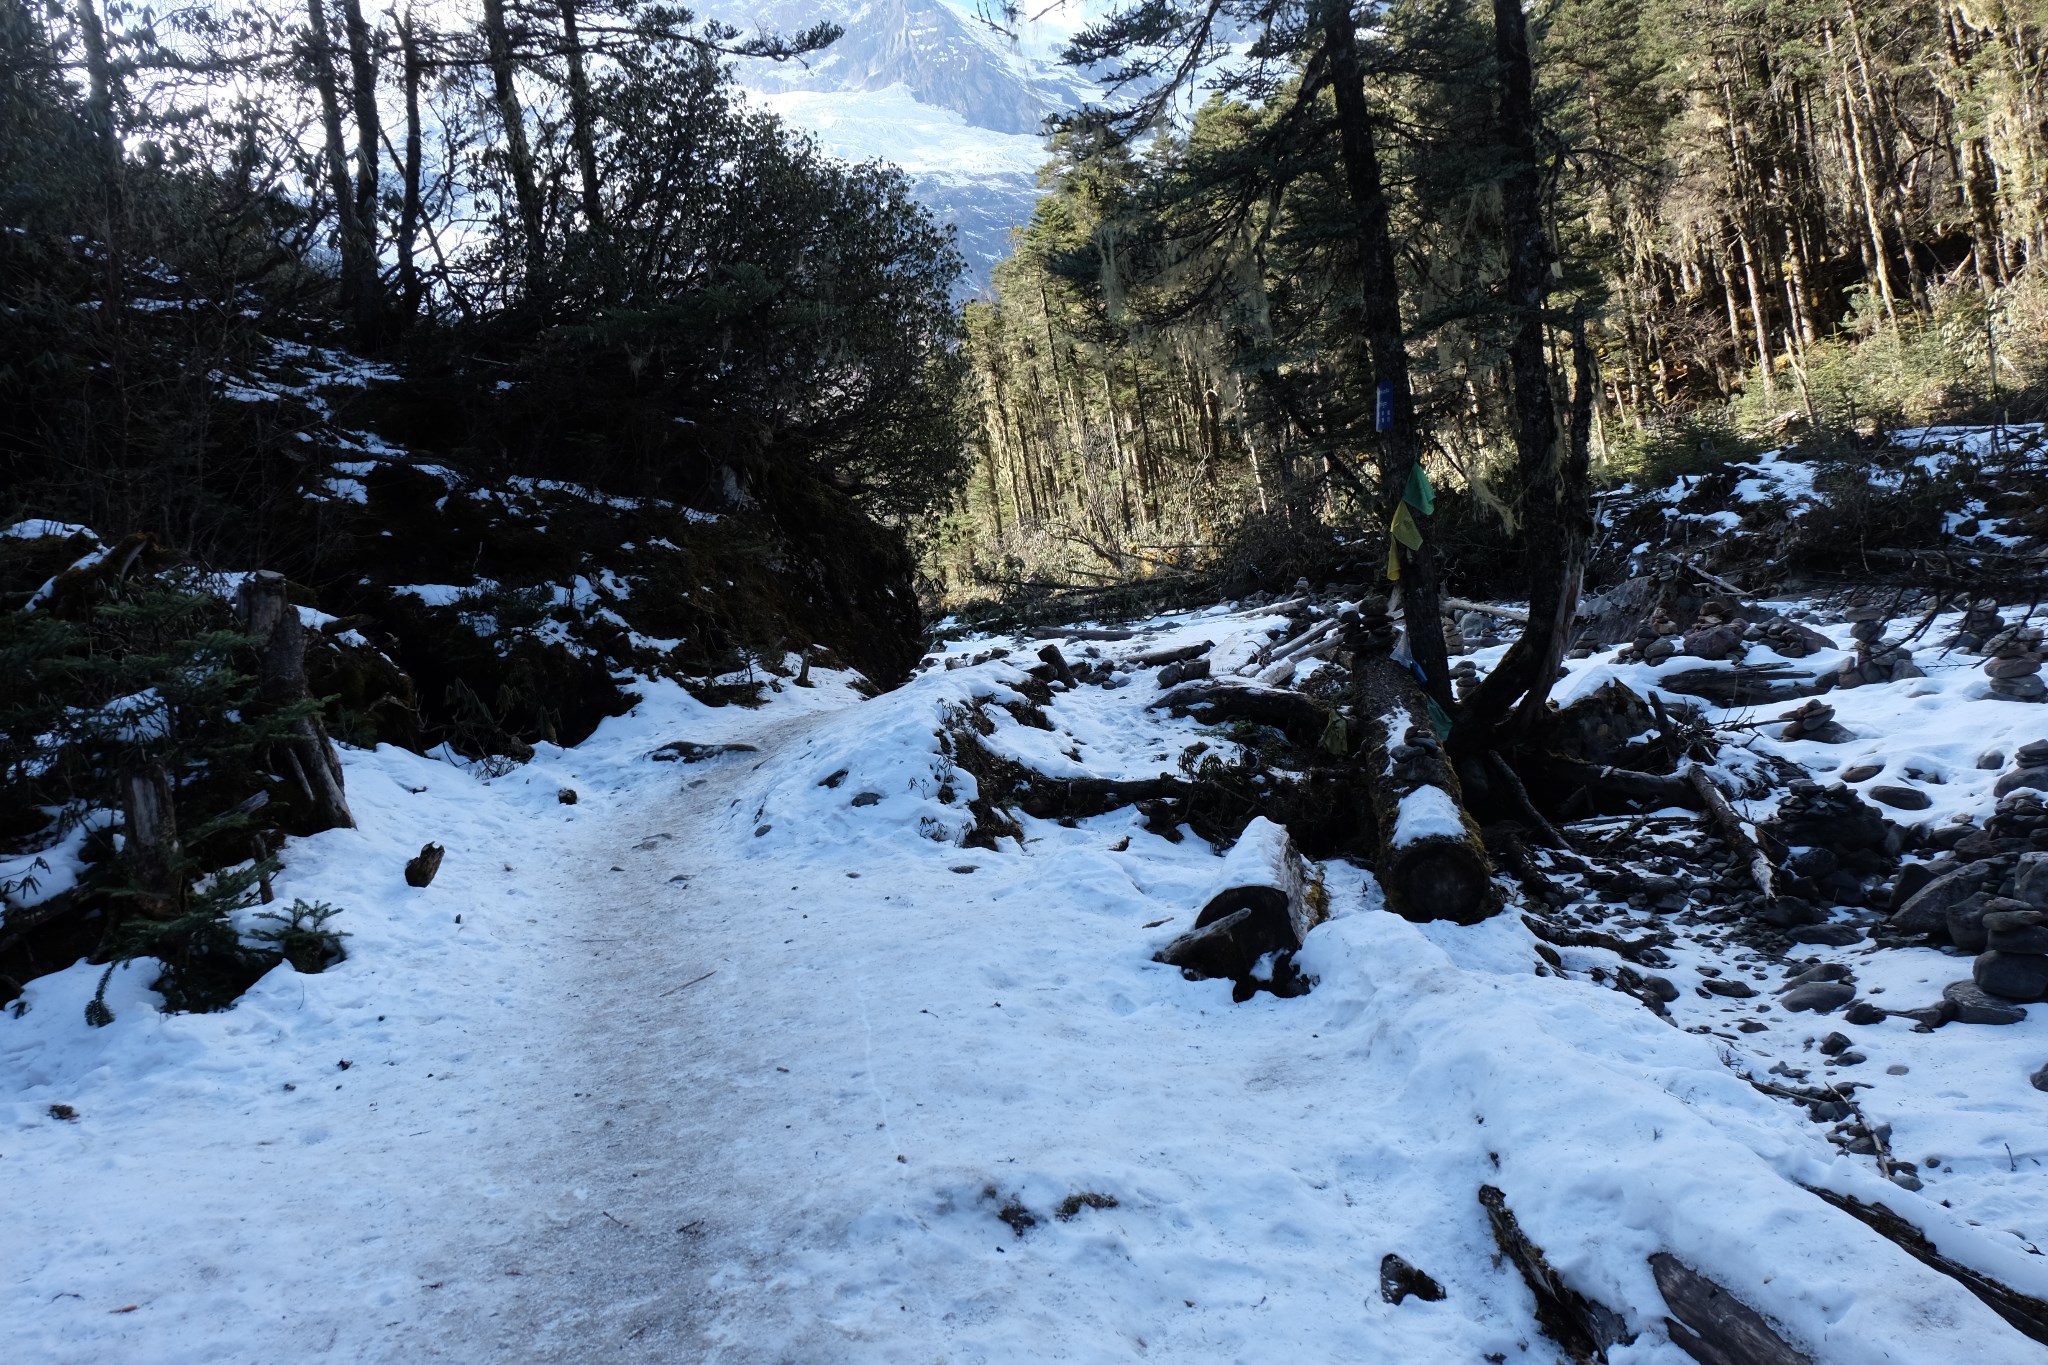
[0,608,2048,1365]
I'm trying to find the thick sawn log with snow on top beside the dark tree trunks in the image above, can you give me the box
[1356,655,1499,925]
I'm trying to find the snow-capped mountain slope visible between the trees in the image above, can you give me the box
[707,0,1104,287]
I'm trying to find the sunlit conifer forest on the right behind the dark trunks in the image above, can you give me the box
[932,0,2048,600]
